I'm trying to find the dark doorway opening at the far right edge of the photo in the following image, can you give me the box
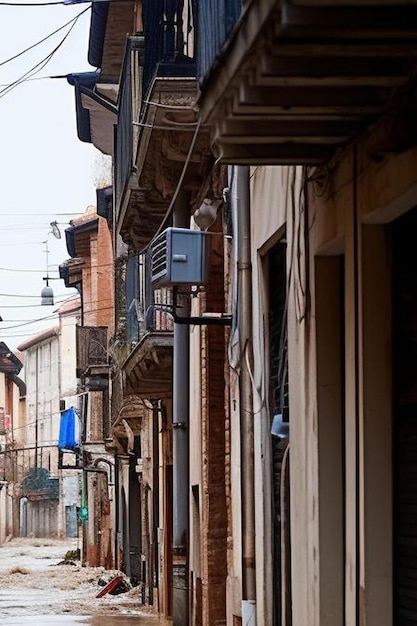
[392,210,417,626]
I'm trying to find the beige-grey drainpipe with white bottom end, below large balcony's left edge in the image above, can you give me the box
[231,166,256,626]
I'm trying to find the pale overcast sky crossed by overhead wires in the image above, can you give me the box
[0,0,102,349]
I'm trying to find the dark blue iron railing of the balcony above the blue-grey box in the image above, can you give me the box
[115,0,197,225]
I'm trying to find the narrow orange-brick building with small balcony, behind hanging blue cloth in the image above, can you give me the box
[60,207,116,569]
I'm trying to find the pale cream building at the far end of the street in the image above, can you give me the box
[15,299,80,537]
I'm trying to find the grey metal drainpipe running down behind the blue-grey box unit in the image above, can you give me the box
[172,193,189,626]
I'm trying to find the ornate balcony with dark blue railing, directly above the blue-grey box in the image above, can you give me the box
[115,0,212,252]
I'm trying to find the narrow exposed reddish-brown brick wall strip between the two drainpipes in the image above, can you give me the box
[201,228,227,626]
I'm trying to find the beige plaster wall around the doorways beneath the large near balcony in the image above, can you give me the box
[245,143,404,626]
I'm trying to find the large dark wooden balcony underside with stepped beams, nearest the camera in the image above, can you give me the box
[199,0,417,165]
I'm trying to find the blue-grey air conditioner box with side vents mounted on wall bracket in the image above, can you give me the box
[150,228,208,287]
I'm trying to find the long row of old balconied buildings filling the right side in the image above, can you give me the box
[69,0,417,626]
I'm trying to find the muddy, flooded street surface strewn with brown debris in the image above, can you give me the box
[0,538,161,626]
